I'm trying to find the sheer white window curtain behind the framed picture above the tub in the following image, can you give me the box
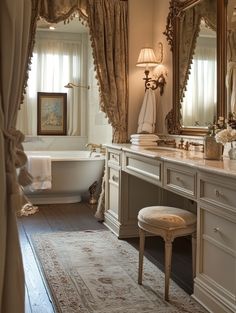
[17,32,87,136]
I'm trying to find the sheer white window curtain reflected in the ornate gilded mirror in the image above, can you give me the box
[182,38,217,126]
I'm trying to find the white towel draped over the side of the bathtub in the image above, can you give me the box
[27,155,52,191]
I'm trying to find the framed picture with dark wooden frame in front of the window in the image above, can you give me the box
[37,92,67,135]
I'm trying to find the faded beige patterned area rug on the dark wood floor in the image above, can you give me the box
[31,231,206,313]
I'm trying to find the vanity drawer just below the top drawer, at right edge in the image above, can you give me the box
[202,209,236,251]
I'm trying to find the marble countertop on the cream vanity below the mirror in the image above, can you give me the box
[106,144,236,179]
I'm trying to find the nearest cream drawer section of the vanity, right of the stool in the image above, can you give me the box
[194,170,236,313]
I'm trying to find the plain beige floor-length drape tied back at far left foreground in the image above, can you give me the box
[0,0,35,313]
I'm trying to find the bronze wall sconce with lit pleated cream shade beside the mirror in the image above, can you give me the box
[136,42,166,96]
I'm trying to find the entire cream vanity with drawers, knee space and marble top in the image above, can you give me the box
[105,145,236,313]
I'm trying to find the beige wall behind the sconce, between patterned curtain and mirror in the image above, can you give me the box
[128,0,172,139]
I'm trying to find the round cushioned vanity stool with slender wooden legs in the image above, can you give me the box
[138,206,197,301]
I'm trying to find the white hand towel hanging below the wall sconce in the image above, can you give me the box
[137,89,156,134]
